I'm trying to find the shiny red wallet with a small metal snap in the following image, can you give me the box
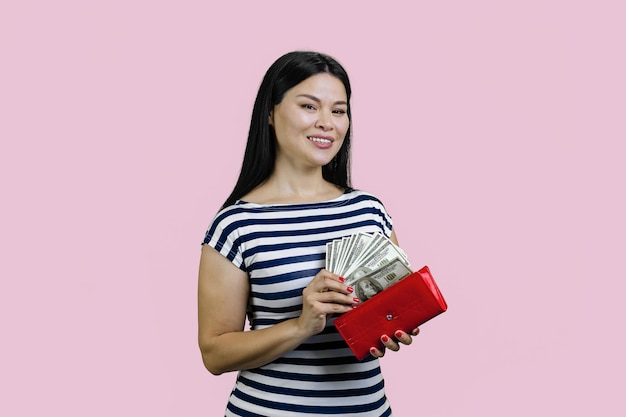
[335,266,448,360]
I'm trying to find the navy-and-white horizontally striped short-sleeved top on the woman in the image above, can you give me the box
[204,190,392,417]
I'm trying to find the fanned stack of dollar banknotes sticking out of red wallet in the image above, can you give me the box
[326,233,413,301]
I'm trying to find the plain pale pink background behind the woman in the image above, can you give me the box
[0,0,626,417]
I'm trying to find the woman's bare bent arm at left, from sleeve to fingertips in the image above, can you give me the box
[198,245,356,375]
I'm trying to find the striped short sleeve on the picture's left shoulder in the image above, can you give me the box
[202,208,245,271]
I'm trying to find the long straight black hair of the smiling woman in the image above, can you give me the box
[222,51,352,208]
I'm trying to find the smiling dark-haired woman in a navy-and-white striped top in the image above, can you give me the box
[198,52,418,417]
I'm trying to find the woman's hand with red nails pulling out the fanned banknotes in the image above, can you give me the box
[298,269,360,336]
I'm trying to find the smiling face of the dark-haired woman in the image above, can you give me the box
[270,73,350,168]
